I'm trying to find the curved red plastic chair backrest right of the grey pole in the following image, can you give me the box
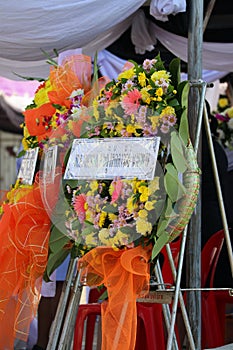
[201,230,225,288]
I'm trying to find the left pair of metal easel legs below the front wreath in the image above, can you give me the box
[47,258,81,350]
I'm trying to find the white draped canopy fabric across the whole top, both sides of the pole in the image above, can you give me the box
[0,0,233,80]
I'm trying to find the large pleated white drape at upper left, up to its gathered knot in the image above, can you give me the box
[0,0,186,80]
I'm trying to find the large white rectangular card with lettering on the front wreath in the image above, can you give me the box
[64,137,160,180]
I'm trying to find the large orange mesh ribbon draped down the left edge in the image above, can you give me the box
[0,171,61,349]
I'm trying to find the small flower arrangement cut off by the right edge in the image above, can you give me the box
[215,107,233,149]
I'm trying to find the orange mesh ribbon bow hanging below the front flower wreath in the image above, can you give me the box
[79,246,151,350]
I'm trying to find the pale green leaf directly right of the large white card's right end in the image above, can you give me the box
[171,131,188,173]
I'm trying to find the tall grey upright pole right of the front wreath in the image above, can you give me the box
[186,0,203,350]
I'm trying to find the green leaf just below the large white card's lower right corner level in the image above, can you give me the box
[164,163,186,203]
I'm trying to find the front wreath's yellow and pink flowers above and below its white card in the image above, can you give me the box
[41,55,198,271]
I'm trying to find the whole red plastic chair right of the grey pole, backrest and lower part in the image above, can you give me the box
[201,230,225,348]
